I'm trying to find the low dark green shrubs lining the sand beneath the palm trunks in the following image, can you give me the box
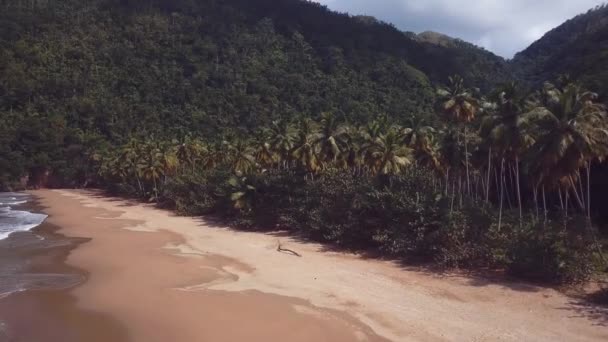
[159,168,595,283]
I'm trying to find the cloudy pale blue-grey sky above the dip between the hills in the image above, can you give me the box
[316,0,605,58]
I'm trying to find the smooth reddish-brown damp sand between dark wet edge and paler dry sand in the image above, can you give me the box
[32,191,386,342]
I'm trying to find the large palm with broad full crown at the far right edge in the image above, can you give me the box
[526,83,608,219]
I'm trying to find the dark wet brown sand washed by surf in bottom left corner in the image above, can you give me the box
[0,223,127,342]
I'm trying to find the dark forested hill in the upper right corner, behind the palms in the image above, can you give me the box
[510,5,608,97]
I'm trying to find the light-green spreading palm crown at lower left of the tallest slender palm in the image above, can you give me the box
[367,127,412,176]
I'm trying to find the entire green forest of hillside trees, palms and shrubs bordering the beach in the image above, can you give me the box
[0,0,608,282]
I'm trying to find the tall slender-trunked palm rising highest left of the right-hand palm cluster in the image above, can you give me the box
[437,76,480,194]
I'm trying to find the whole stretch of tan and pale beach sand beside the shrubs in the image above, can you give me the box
[33,191,608,342]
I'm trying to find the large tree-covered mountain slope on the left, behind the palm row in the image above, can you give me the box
[0,0,505,186]
